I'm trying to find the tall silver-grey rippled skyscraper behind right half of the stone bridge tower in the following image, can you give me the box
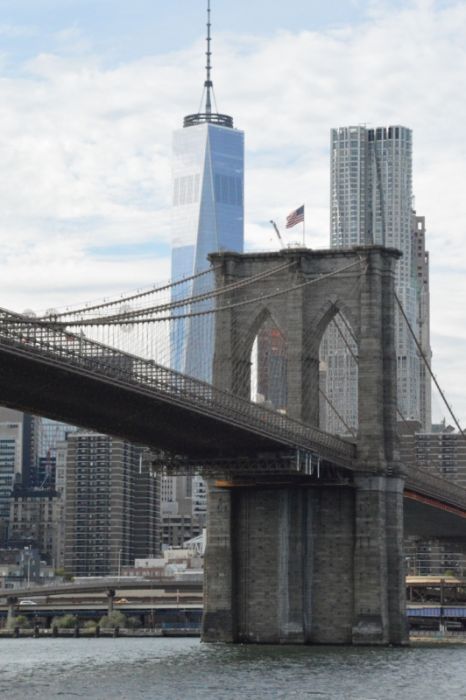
[321,125,430,433]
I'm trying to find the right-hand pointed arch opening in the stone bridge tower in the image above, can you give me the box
[319,305,359,438]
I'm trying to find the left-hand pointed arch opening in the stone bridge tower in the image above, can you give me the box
[250,314,288,413]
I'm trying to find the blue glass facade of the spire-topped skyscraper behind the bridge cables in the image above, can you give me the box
[171,123,244,381]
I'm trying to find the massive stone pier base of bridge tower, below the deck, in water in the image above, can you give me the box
[202,475,407,645]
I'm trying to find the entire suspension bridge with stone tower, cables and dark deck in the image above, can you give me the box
[0,246,466,644]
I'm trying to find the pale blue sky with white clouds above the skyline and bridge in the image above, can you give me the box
[0,0,466,425]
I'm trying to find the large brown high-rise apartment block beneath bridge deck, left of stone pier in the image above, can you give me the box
[63,432,160,576]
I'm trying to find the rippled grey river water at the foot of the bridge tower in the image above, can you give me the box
[0,638,466,700]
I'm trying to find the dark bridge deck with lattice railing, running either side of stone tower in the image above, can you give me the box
[0,309,466,514]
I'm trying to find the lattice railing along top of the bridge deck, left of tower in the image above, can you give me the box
[0,309,356,466]
